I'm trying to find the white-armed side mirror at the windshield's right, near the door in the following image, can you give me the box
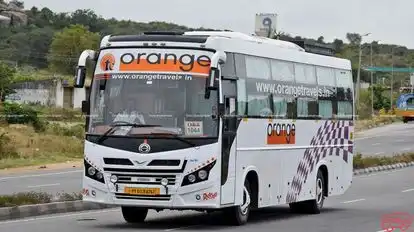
[205,51,227,99]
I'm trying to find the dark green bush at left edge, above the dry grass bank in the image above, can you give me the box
[3,102,46,132]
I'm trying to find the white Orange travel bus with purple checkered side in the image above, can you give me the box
[75,32,354,225]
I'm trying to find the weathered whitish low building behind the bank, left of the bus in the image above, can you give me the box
[6,79,89,108]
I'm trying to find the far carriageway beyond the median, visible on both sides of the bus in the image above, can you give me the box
[0,123,414,195]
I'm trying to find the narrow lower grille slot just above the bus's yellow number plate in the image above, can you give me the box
[117,174,176,185]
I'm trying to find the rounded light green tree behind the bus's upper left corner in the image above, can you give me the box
[48,24,100,74]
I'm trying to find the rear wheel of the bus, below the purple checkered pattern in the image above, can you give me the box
[289,170,326,214]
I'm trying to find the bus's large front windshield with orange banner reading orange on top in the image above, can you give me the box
[88,48,218,137]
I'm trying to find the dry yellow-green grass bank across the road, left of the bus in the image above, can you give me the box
[0,124,84,169]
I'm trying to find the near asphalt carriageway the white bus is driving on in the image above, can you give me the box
[0,168,414,232]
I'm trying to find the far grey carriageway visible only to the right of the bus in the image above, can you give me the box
[355,123,414,156]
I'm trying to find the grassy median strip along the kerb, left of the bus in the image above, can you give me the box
[0,192,82,208]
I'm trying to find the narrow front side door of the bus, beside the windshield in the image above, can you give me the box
[220,80,239,205]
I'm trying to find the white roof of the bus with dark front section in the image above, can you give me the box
[101,31,351,70]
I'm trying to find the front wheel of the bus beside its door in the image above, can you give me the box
[223,179,252,226]
